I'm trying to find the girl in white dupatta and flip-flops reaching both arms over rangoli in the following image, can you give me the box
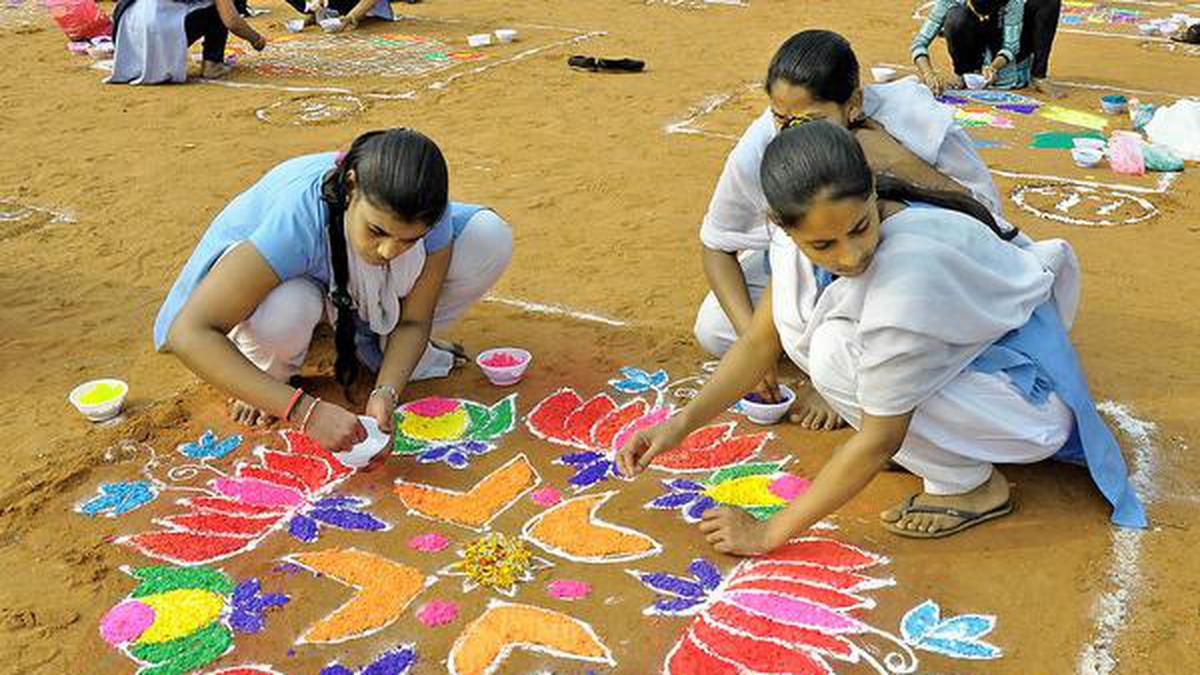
[618,123,1146,555]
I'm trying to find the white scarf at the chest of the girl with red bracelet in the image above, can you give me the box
[325,238,425,335]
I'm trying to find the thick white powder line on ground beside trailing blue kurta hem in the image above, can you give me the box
[1078,400,1158,675]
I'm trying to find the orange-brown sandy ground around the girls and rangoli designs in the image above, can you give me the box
[0,0,1200,674]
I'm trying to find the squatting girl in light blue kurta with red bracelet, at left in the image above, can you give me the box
[154,129,512,452]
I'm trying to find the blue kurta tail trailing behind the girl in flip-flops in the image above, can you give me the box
[970,303,1147,527]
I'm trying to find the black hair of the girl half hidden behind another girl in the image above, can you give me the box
[763,30,859,106]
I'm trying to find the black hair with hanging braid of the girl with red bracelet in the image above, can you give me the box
[320,129,450,388]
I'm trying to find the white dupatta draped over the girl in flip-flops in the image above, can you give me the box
[770,208,1079,414]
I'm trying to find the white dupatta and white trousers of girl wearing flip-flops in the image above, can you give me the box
[770,208,1079,495]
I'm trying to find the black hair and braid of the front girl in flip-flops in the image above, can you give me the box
[760,120,1016,240]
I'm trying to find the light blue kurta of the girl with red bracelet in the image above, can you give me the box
[154,153,482,350]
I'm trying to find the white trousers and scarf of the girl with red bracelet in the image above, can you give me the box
[229,209,512,382]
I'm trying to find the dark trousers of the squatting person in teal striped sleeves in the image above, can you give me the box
[942,0,1062,79]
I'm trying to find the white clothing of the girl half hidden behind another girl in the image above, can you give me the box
[694,78,1010,356]
